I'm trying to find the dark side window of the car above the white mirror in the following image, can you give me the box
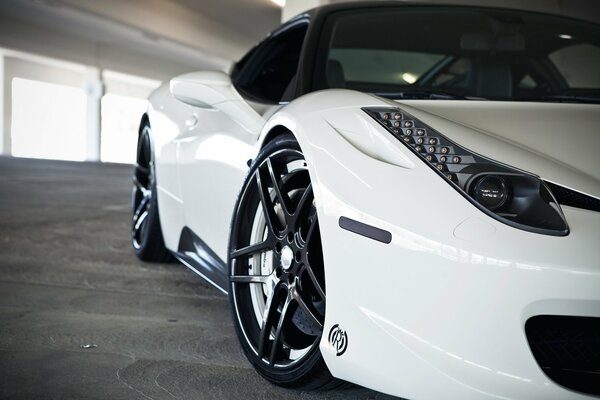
[235,23,308,103]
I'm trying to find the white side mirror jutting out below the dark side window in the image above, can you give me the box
[170,71,262,134]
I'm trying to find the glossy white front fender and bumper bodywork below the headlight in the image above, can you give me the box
[259,90,600,399]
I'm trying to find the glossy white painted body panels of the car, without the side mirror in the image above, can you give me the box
[149,82,600,400]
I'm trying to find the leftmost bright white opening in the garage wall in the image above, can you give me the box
[11,78,87,161]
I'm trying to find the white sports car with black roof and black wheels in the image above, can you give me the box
[132,2,600,400]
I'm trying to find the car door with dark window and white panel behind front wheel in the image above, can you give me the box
[178,22,308,268]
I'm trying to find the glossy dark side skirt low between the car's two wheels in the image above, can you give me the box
[173,227,229,294]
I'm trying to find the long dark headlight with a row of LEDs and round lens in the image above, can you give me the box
[363,107,569,236]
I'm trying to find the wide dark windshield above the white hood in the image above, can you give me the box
[315,6,600,102]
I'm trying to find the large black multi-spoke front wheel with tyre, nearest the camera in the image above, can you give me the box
[229,135,335,389]
